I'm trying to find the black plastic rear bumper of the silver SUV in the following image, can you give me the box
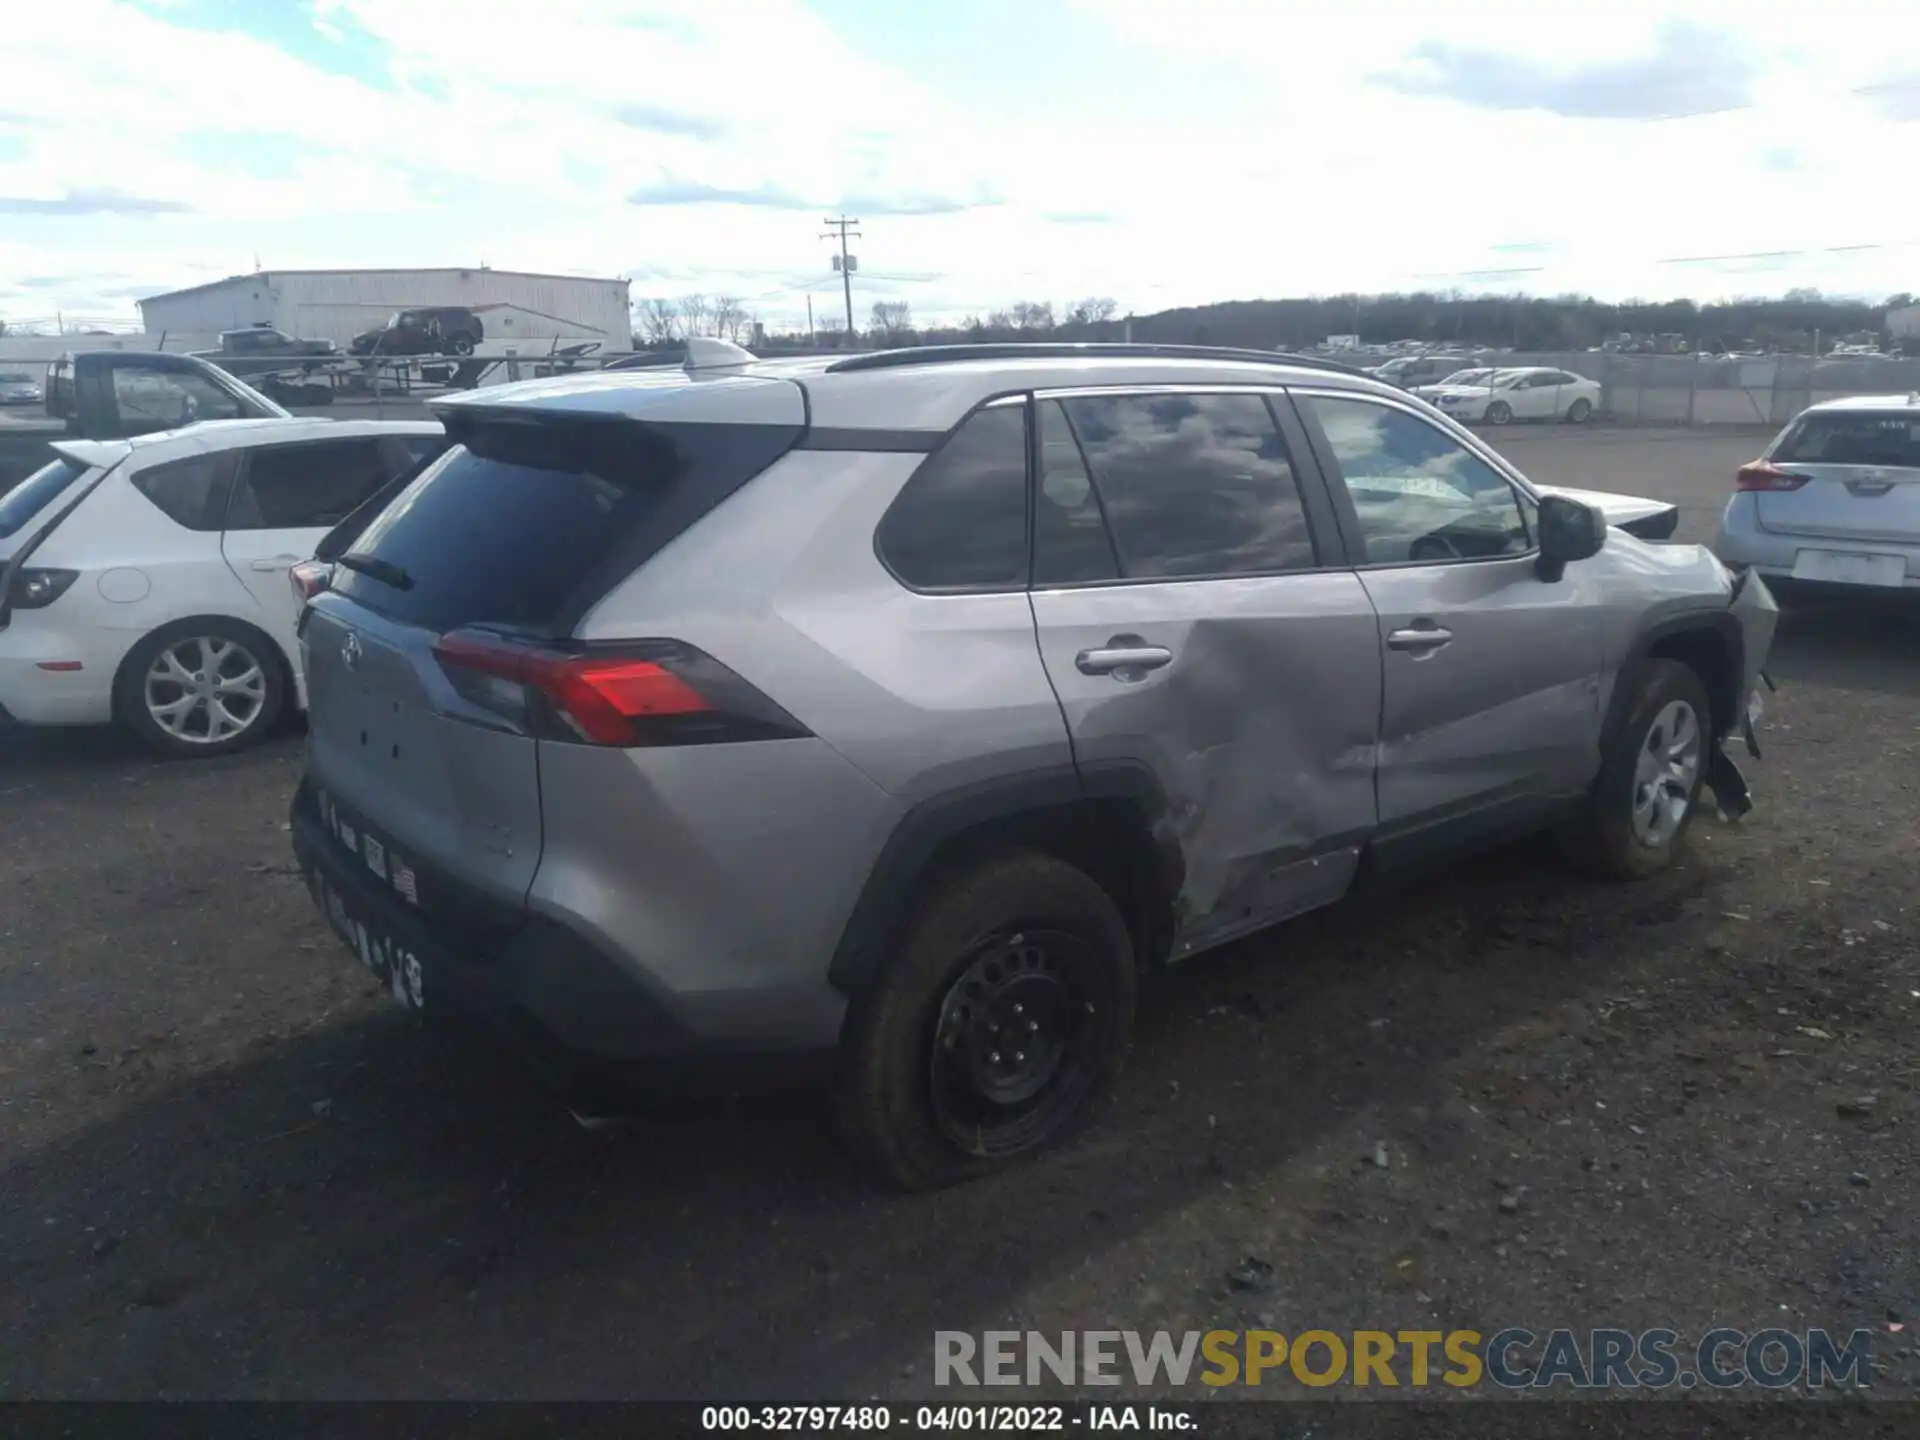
[292,781,835,1114]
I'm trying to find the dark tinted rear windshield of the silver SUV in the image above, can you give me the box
[334,415,799,634]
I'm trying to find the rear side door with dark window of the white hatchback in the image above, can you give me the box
[221,436,409,653]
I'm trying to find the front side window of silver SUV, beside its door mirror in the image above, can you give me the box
[1302,396,1530,564]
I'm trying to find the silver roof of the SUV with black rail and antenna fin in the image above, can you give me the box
[430,342,1405,432]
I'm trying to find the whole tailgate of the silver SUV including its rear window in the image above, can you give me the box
[297,378,804,925]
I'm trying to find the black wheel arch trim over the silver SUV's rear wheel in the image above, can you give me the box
[828,760,1187,995]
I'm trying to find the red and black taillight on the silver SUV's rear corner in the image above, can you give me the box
[434,630,808,747]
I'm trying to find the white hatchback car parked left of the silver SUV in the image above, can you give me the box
[0,419,445,755]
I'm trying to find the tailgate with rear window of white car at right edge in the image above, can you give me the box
[1755,409,1920,551]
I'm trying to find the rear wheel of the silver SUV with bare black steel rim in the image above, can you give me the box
[835,851,1137,1190]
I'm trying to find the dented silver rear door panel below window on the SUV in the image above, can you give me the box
[1033,570,1380,954]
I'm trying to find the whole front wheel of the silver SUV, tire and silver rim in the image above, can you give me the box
[1563,660,1713,879]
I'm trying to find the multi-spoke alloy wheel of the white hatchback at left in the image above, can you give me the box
[113,618,286,756]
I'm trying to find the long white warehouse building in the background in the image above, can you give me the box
[140,265,634,351]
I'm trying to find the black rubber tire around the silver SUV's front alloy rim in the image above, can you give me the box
[1559,660,1713,879]
